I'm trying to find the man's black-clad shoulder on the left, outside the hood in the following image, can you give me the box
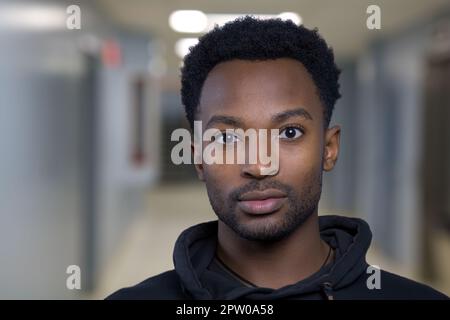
[106,270,186,300]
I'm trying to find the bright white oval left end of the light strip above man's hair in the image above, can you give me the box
[169,10,208,33]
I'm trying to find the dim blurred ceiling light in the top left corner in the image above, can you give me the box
[0,4,67,30]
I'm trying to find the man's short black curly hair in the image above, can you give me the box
[181,16,341,128]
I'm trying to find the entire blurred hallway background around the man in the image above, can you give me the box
[0,0,450,299]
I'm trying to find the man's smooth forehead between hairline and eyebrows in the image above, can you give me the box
[198,58,323,122]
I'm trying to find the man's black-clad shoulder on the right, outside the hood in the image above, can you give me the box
[341,270,448,300]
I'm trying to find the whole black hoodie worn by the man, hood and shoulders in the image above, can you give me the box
[107,216,448,300]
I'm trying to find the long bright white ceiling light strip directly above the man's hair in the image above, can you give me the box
[169,10,302,33]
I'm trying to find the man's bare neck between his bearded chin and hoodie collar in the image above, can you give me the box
[217,213,329,289]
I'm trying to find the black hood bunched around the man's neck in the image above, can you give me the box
[173,216,372,300]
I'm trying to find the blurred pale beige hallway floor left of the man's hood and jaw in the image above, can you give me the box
[88,183,215,299]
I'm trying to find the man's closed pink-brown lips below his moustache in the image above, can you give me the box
[238,189,287,215]
